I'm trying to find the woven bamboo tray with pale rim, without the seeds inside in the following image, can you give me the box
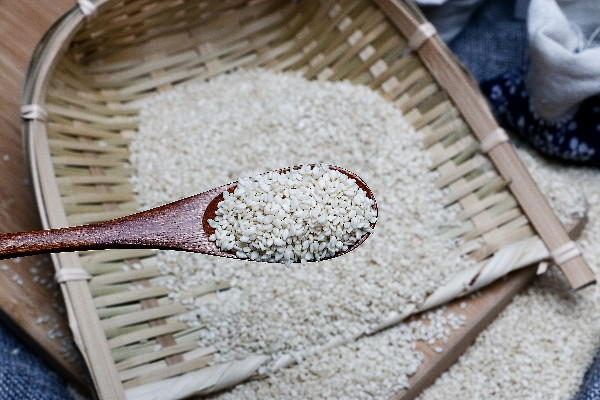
[22,0,595,399]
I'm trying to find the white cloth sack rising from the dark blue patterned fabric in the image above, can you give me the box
[527,0,600,121]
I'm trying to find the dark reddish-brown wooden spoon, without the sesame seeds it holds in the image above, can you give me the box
[0,166,377,259]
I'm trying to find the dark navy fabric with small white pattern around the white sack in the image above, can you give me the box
[481,64,600,165]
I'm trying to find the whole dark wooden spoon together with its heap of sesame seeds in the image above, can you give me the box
[0,164,377,266]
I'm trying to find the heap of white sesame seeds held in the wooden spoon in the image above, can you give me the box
[208,164,377,267]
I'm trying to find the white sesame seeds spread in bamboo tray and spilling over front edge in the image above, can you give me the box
[130,70,465,398]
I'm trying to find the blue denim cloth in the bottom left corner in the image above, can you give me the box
[0,324,71,400]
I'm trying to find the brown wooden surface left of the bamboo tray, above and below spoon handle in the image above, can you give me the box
[0,0,89,390]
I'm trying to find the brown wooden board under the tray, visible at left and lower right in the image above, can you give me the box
[0,0,552,399]
